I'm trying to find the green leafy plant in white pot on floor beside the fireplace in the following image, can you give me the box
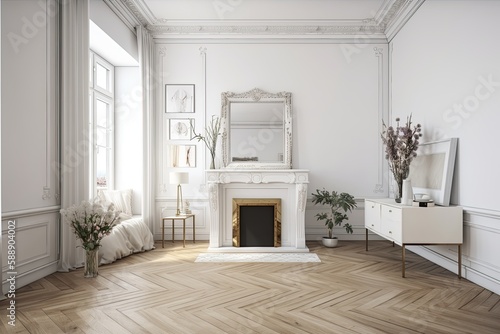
[312,188,356,247]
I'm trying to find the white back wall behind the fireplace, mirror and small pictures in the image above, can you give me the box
[154,41,388,243]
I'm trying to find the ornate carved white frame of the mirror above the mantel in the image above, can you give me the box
[221,88,292,169]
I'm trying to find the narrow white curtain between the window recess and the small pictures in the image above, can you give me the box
[136,26,155,231]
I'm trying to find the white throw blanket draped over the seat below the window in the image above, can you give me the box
[99,217,154,264]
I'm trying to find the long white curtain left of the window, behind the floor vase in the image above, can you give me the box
[59,0,91,271]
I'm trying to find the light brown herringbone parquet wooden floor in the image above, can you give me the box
[0,241,500,334]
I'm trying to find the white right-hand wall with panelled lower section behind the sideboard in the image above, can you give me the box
[390,0,500,293]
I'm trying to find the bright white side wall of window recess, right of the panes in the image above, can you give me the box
[115,66,143,214]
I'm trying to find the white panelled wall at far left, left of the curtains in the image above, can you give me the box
[1,0,60,291]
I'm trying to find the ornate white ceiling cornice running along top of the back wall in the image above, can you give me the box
[113,0,424,41]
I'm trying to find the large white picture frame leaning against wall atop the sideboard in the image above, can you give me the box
[408,138,458,206]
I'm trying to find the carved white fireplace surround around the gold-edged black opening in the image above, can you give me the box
[207,169,309,252]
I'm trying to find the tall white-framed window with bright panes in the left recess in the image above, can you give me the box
[89,52,114,196]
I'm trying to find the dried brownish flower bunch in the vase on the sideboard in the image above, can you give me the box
[380,114,422,199]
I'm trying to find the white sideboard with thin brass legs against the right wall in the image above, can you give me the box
[365,198,463,278]
